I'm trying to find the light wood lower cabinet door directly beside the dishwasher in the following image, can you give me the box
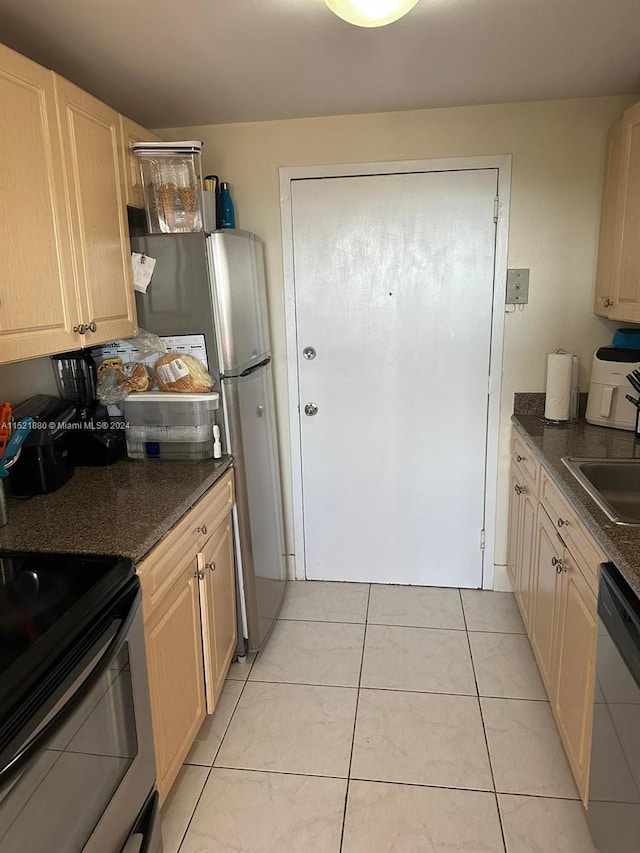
[552,552,598,804]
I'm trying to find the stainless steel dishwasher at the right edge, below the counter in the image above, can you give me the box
[587,563,640,853]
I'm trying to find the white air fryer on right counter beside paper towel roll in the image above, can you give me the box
[585,338,640,431]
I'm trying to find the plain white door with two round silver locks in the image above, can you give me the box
[292,168,498,587]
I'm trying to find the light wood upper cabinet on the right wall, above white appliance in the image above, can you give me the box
[594,103,640,323]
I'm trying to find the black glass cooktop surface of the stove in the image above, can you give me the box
[0,552,134,722]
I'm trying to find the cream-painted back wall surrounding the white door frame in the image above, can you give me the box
[158,97,636,578]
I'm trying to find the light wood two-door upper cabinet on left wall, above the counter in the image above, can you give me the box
[0,45,136,363]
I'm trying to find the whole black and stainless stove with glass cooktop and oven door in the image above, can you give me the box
[0,551,162,853]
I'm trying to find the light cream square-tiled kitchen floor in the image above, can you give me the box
[162,581,595,853]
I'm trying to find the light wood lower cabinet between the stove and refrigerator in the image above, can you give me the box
[137,471,237,802]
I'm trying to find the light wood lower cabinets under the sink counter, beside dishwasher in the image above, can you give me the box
[508,430,606,804]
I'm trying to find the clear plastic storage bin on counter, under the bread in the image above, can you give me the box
[123,391,220,459]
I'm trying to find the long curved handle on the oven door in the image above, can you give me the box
[0,587,142,786]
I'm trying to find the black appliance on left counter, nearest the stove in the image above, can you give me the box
[9,394,75,497]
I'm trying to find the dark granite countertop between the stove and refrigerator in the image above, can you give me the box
[0,456,233,562]
